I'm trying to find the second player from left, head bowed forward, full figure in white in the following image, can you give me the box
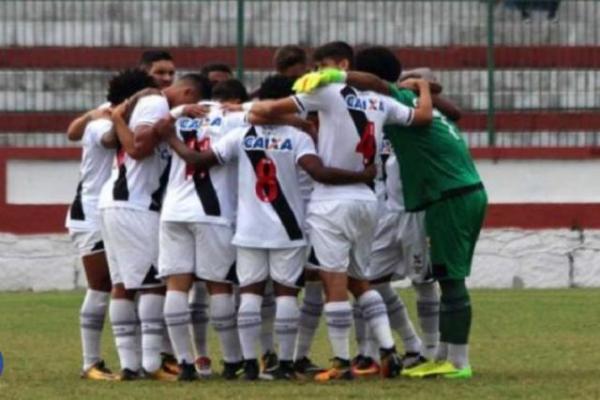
[99,75,209,380]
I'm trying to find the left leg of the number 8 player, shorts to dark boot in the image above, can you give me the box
[237,247,269,380]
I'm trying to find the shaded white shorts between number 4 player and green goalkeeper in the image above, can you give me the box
[369,211,430,282]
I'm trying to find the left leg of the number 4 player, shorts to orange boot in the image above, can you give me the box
[307,202,352,381]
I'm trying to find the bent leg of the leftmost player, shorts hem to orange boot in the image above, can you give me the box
[71,232,116,380]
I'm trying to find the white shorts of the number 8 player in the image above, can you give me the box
[237,246,306,288]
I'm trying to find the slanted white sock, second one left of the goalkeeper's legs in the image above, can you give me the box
[373,282,422,353]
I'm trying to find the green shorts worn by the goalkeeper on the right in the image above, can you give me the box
[425,187,487,280]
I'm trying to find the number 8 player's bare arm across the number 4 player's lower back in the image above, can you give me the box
[298,154,377,185]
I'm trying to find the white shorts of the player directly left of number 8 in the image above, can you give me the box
[158,221,236,282]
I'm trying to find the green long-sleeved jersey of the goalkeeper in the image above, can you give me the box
[385,85,481,211]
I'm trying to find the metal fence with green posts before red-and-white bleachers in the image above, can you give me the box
[0,0,600,147]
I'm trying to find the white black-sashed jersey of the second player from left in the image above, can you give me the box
[99,94,170,212]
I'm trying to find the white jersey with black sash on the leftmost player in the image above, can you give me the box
[65,112,115,231]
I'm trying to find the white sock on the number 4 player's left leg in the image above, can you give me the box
[325,301,352,360]
